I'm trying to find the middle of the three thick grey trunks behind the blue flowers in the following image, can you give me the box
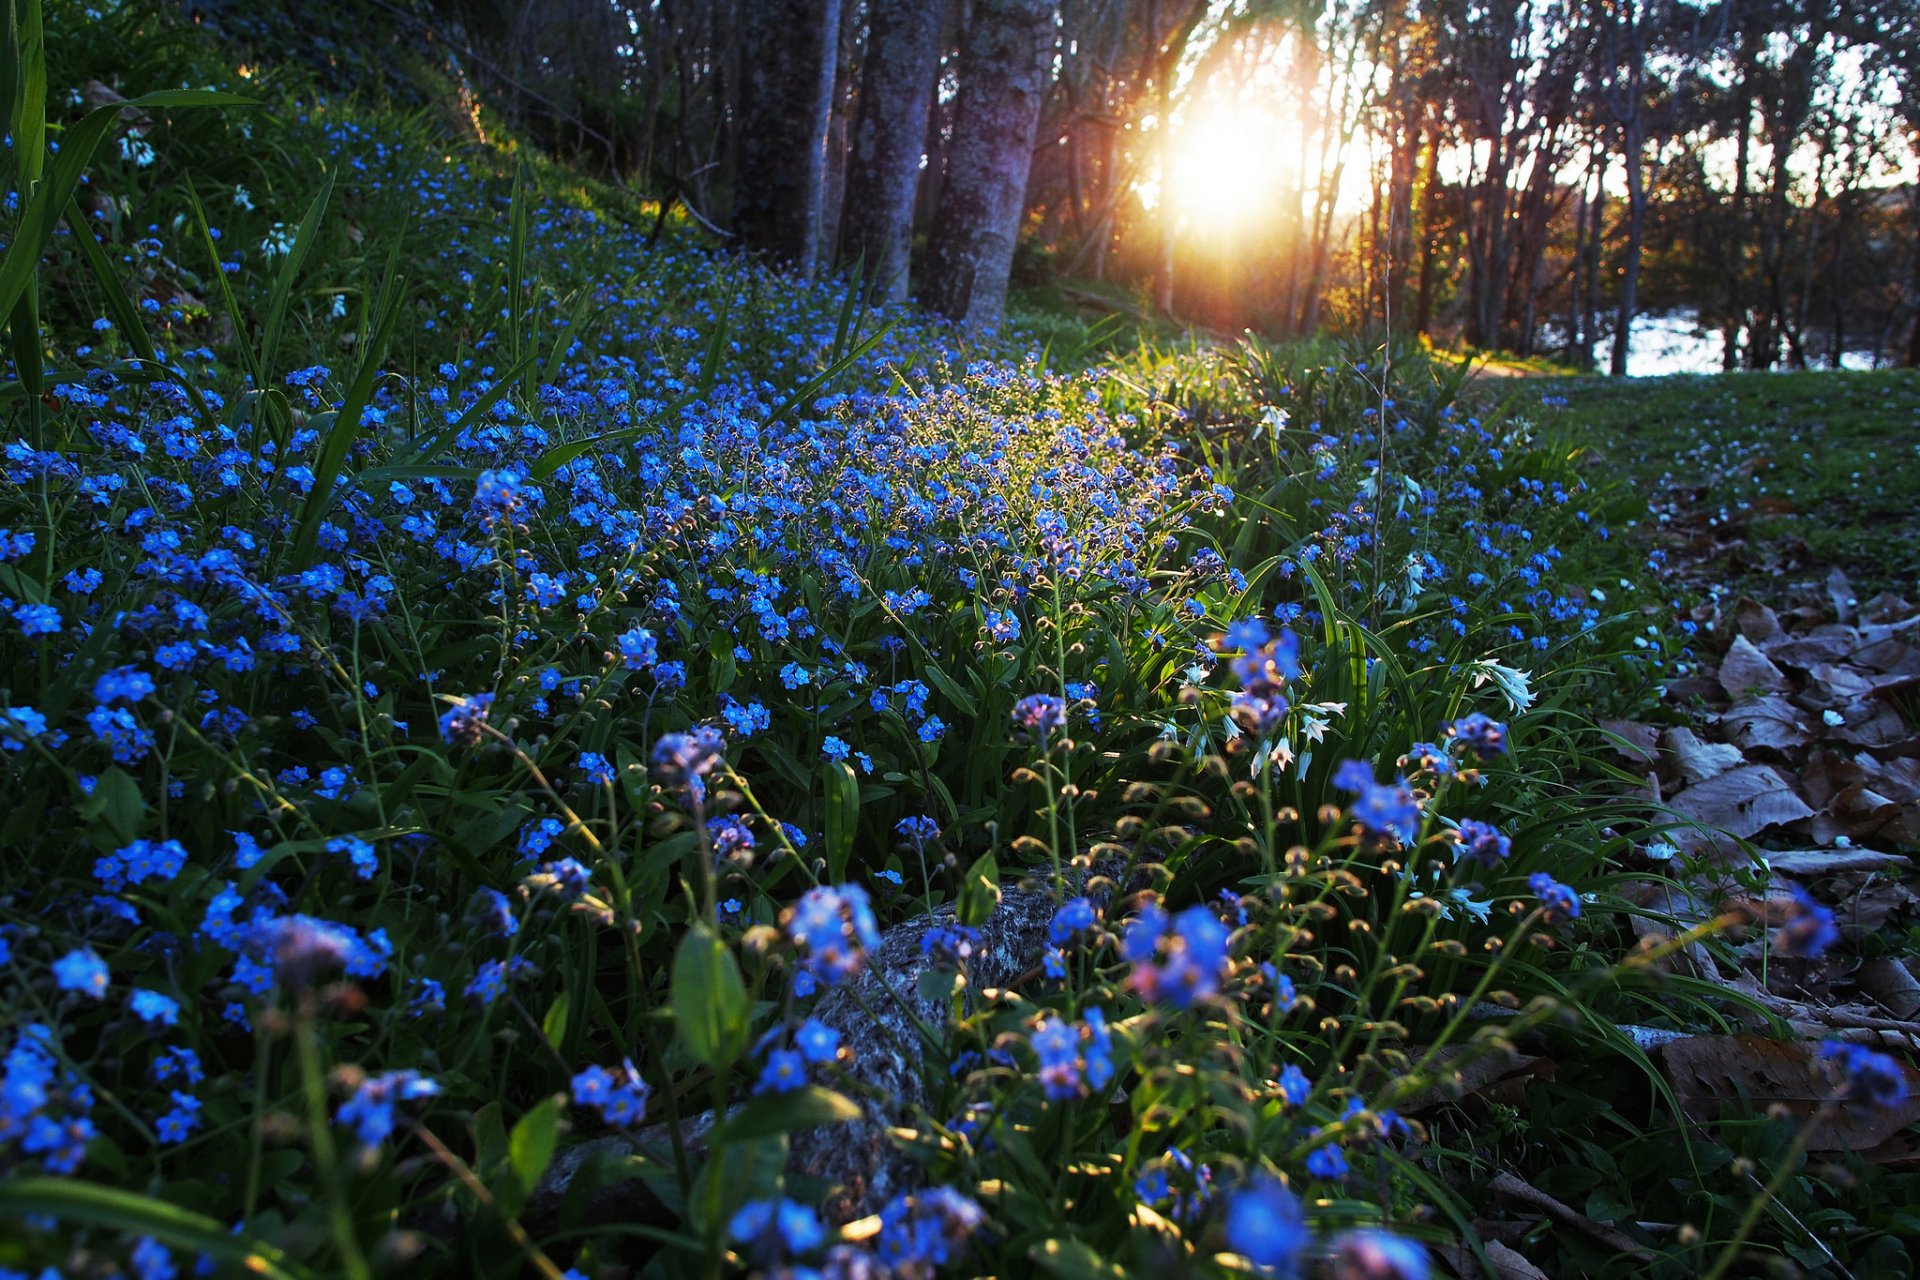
[839,0,947,301]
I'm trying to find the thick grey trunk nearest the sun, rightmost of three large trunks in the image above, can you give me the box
[922,0,1054,334]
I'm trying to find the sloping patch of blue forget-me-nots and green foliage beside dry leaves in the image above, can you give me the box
[0,4,1912,1280]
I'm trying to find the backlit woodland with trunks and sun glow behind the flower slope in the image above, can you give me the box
[428,0,1920,370]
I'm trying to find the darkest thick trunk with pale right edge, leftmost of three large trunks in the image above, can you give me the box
[733,0,841,276]
